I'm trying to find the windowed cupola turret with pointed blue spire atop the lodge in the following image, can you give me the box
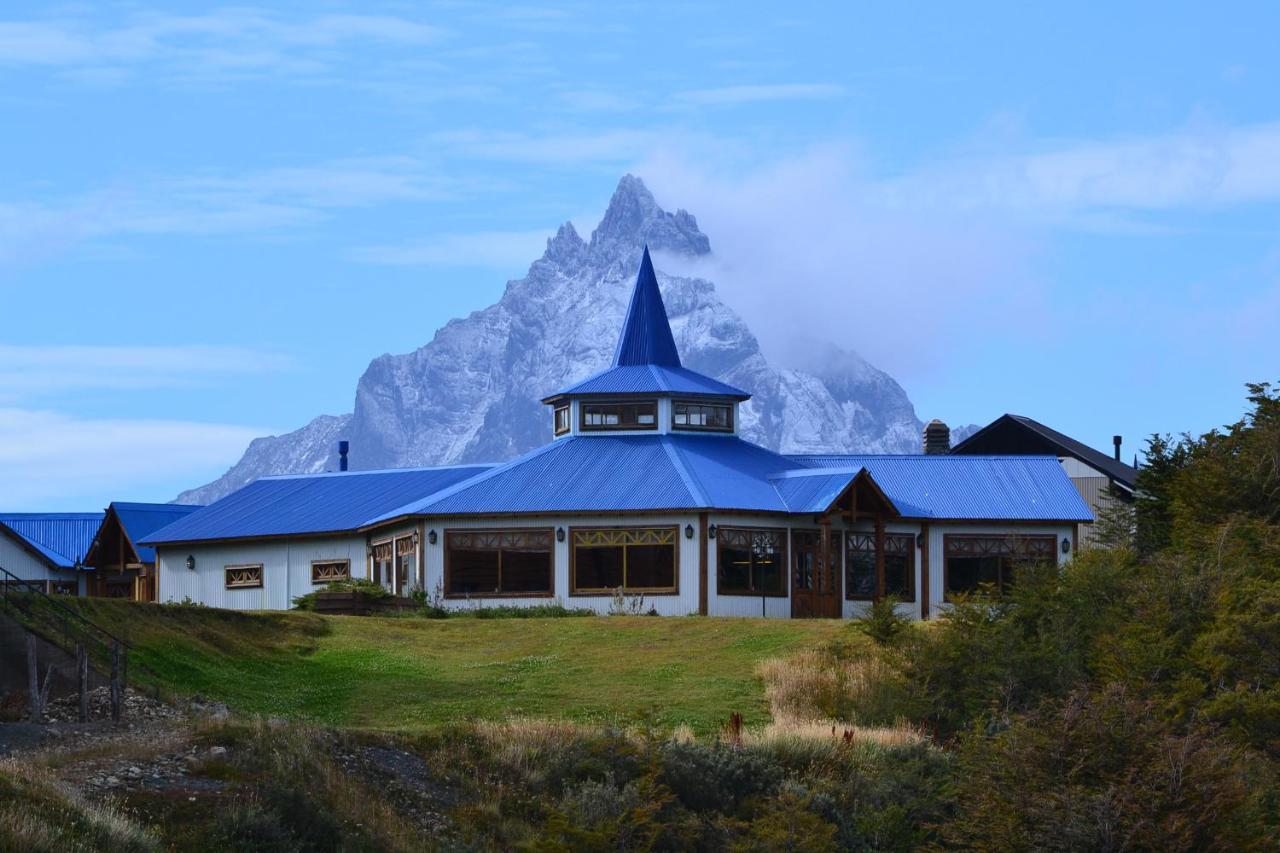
[543,246,750,435]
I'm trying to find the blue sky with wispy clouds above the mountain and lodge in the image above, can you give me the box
[0,3,1280,510]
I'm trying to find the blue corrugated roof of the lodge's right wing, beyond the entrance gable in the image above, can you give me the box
[790,455,1093,521]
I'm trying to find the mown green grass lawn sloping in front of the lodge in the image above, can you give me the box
[62,599,849,733]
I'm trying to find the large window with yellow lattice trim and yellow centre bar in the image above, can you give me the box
[572,528,676,593]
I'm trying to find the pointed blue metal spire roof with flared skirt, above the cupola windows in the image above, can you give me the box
[543,246,751,402]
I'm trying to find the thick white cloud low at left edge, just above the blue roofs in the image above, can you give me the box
[0,407,270,510]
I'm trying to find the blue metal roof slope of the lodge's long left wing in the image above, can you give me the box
[134,465,489,547]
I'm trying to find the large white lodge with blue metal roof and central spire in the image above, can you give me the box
[136,250,1092,619]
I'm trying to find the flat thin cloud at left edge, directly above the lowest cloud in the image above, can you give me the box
[0,343,296,401]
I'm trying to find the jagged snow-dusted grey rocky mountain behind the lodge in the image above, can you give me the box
[178,175,922,503]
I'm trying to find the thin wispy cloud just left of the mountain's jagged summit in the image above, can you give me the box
[348,228,554,270]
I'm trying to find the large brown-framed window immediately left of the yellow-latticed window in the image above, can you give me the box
[444,529,553,597]
